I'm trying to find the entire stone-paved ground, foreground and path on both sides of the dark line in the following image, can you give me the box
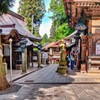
[0,64,100,100]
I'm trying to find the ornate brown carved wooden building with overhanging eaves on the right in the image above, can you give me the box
[63,0,100,72]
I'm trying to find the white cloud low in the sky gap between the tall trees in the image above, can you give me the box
[39,20,52,36]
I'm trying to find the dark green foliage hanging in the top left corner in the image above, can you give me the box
[0,0,15,14]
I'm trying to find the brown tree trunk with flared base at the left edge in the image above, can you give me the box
[0,36,10,91]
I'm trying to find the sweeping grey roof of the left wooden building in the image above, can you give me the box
[0,11,41,41]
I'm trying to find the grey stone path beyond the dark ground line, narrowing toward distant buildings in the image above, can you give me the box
[13,64,100,84]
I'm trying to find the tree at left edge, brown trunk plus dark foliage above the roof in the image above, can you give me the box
[0,0,15,90]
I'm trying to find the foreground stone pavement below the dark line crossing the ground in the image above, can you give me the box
[0,84,100,100]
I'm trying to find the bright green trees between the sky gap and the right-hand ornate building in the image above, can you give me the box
[49,0,74,42]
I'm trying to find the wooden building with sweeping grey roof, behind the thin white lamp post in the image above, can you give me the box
[0,11,41,68]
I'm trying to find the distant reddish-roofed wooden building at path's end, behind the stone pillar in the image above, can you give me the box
[42,33,77,63]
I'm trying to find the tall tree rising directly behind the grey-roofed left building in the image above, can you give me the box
[18,0,45,34]
